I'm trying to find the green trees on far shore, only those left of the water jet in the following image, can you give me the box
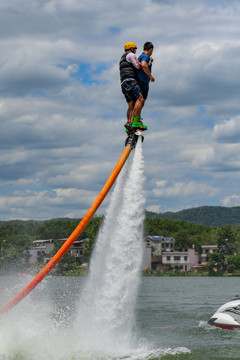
[0,216,103,272]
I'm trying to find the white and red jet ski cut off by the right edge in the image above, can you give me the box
[208,295,240,330]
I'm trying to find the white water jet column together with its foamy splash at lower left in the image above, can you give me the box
[0,138,193,360]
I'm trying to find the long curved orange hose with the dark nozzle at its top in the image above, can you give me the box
[0,128,143,313]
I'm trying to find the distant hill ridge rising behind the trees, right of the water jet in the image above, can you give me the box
[146,206,240,226]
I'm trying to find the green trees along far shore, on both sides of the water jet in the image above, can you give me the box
[0,216,240,276]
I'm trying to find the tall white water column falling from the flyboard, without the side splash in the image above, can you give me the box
[78,137,145,351]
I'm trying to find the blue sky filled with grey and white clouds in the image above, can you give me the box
[0,0,240,220]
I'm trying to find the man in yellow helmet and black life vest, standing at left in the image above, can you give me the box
[119,42,147,133]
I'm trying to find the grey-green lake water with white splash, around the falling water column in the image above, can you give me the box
[0,276,240,360]
